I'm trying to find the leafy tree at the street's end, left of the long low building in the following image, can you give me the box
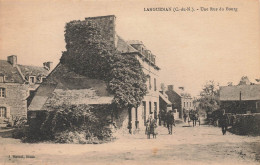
[198,81,219,113]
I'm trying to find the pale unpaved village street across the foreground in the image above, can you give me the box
[0,120,260,165]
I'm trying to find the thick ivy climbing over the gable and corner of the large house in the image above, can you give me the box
[61,21,147,108]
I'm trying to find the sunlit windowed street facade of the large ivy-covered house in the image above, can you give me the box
[126,40,160,132]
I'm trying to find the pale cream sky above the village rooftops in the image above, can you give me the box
[0,0,260,96]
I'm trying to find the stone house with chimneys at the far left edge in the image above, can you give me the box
[0,55,52,122]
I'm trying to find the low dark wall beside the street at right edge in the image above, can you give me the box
[230,113,260,135]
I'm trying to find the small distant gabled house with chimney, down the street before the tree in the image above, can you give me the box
[166,85,196,119]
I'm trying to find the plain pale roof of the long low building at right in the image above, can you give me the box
[220,84,260,101]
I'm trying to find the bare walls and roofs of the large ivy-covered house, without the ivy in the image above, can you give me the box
[29,15,160,133]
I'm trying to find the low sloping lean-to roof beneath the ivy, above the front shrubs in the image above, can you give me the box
[28,64,114,111]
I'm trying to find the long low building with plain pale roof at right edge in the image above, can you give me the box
[220,84,260,114]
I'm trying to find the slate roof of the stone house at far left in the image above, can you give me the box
[0,60,49,84]
